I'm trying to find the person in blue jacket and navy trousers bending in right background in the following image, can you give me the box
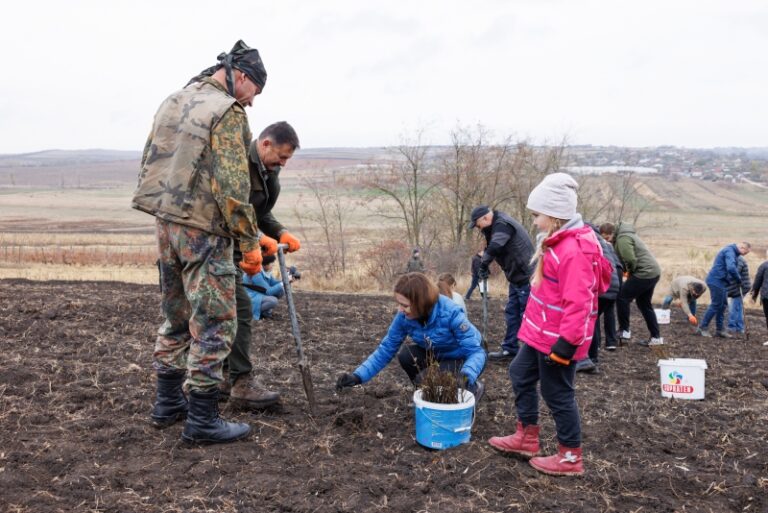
[697,242,752,338]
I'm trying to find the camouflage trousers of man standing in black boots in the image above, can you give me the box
[154,219,237,389]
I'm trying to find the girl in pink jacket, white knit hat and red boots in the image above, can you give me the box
[489,173,612,475]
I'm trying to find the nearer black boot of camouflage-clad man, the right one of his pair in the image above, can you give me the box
[181,388,251,444]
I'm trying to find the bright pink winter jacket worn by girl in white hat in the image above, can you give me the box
[517,226,612,360]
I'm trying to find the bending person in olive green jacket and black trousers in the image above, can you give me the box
[613,223,664,346]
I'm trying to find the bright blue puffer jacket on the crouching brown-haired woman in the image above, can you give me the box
[355,295,485,385]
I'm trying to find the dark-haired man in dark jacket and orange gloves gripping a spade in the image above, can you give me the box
[220,121,301,409]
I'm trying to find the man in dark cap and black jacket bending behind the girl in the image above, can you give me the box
[469,205,533,360]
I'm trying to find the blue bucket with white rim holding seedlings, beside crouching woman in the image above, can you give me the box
[413,390,475,449]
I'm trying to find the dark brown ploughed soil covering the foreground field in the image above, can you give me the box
[0,280,768,513]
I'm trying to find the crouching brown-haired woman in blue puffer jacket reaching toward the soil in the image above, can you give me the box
[336,273,486,401]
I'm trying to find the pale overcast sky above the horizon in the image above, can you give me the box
[0,0,768,153]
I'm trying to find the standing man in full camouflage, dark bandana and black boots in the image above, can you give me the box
[132,41,267,443]
